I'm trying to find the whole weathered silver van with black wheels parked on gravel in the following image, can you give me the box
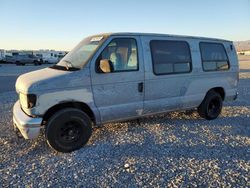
[13,33,239,152]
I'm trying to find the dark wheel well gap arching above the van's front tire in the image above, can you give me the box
[43,102,95,123]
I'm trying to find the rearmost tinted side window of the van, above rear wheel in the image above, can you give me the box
[200,42,229,71]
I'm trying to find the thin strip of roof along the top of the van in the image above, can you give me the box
[95,32,232,42]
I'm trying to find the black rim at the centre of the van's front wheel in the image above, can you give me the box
[59,121,81,143]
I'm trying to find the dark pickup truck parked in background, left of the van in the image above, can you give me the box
[9,54,42,65]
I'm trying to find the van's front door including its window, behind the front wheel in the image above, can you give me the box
[91,36,144,123]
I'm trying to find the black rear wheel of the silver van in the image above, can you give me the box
[198,90,223,120]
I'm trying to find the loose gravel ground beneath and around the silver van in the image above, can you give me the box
[0,62,250,187]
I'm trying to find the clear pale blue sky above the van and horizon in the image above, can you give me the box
[0,0,250,50]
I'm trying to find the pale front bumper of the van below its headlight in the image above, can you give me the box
[13,101,42,139]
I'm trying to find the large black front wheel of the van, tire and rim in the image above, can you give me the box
[45,108,92,152]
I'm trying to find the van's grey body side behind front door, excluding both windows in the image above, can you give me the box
[141,36,239,114]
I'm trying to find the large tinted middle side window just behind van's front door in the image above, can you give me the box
[150,40,191,75]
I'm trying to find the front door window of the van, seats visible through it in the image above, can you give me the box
[96,38,138,72]
